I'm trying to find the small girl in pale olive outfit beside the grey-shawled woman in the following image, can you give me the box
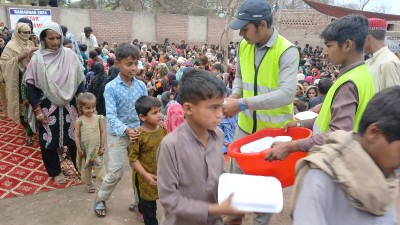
[75,92,106,193]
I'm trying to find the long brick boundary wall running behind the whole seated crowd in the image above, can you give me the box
[0,5,400,46]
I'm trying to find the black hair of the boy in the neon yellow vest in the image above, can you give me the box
[320,15,368,53]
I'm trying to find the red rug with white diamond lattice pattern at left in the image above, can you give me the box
[0,115,80,199]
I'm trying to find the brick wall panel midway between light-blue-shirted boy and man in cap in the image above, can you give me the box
[155,14,189,44]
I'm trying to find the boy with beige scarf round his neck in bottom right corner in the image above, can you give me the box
[293,86,400,225]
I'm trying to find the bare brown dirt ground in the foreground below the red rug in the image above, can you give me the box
[0,159,400,225]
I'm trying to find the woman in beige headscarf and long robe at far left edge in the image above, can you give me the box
[0,23,37,141]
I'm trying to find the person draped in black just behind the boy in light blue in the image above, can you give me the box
[87,62,107,116]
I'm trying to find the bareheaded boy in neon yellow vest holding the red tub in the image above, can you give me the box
[265,15,375,161]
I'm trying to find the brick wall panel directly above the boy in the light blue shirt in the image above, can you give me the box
[90,10,132,44]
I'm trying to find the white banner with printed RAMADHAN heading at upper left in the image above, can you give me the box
[9,8,52,34]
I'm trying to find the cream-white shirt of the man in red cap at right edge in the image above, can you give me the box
[365,46,400,93]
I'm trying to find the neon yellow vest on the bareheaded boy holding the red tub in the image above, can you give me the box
[313,64,375,135]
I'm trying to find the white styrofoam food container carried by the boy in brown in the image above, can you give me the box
[218,173,283,213]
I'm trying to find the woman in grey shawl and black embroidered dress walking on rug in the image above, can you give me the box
[25,22,85,183]
